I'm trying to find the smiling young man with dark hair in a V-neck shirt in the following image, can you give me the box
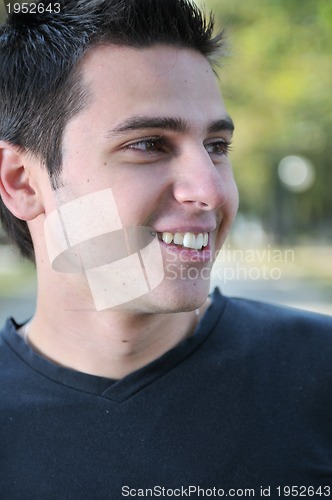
[0,0,332,494]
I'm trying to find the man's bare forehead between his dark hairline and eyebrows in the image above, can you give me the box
[75,45,225,131]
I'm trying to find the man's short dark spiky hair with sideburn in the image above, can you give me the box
[0,0,223,260]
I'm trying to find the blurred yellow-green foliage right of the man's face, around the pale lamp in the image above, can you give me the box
[200,0,332,241]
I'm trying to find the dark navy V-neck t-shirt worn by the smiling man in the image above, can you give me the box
[0,290,332,500]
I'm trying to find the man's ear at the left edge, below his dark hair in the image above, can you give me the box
[0,141,44,221]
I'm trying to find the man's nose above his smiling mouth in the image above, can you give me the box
[173,147,230,211]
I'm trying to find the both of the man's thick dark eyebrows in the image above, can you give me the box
[106,115,234,137]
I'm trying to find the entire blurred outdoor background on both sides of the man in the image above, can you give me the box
[0,0,332,322]
